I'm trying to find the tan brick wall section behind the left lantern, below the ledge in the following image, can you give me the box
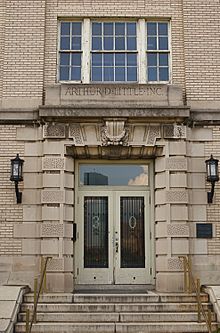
[0,125,24,256]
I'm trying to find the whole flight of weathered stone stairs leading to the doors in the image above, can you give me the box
[15,292,217,333]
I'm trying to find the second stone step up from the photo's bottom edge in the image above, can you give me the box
[18,312,215,323]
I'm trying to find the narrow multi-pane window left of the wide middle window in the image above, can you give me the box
[59,22,82,81]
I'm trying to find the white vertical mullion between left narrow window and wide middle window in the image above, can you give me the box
[82,19,91,83]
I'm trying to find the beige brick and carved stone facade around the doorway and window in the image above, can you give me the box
[0,0,220,291]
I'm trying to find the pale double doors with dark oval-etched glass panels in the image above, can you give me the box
[76,190,150,284]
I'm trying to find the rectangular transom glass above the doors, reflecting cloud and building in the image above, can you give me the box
[80,164,149,186]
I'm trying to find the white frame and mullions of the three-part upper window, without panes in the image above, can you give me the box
[57,18,172,84]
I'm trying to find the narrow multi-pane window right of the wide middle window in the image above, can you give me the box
[147,22,169,82]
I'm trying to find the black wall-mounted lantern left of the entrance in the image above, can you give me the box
[10,154,24,203]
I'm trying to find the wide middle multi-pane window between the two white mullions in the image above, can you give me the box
[91,22,137,82]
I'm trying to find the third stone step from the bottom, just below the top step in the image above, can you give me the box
[21,303,211,313]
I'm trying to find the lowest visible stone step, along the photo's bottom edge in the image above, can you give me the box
[15,322,216,333]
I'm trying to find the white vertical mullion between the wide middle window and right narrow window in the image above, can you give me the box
[137,19,147,83]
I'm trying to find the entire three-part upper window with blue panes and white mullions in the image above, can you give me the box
[58,19,170,83]
